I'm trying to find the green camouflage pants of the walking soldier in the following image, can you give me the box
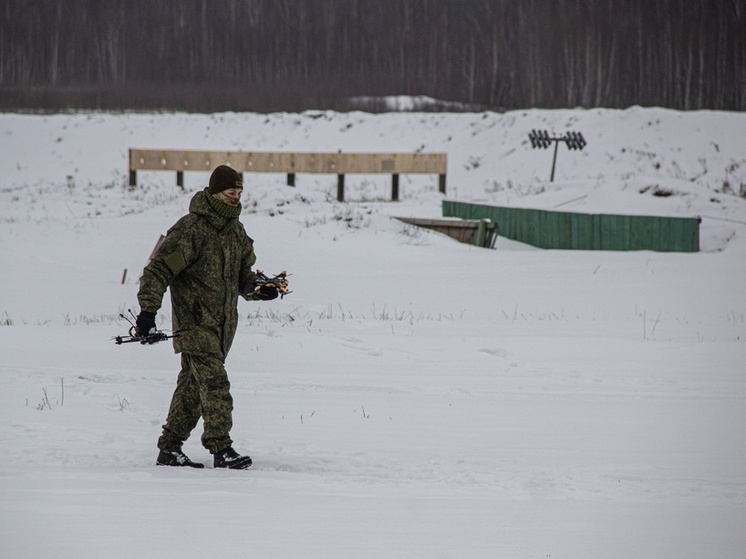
[158,353,233,454]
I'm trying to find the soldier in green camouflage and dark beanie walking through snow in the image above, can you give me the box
[136,165,278,469]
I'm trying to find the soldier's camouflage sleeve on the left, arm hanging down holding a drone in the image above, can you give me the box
[137,216,196,313]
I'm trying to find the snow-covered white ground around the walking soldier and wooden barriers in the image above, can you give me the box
[0,107,746,559]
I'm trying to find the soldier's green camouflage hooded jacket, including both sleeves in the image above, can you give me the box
[137,190,256,361]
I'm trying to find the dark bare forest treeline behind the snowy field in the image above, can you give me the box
[0,0,746,111]
